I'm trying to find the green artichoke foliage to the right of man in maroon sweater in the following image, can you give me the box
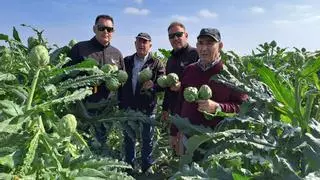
[171,42,320,179]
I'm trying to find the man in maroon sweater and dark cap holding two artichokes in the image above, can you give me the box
[171,28,248,153]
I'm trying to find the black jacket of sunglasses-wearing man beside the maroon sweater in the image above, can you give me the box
[162,45,199,113]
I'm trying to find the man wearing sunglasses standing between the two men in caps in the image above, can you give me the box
[162,22,199,153]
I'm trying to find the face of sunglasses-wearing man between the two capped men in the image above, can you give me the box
[168,25,188,50]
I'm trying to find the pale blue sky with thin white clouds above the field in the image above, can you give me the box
[0,0,320,56]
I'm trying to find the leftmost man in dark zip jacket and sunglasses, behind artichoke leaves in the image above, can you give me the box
[66,15,124,149]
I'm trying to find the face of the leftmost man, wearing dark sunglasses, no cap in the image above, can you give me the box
[93,18,114,46]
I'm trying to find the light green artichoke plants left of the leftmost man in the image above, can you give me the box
[0,26,132,179]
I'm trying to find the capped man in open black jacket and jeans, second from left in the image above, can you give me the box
[119,33,165,172]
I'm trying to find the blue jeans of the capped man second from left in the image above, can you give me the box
[124,115,154,172]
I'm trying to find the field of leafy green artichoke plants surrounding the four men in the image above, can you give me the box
[0,25,320,180]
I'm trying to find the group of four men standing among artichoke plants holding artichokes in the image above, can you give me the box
[68,15,247,172]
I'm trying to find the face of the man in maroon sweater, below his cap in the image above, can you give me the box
[197,36,223,63]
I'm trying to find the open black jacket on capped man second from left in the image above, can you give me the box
[119,54,165,115]
